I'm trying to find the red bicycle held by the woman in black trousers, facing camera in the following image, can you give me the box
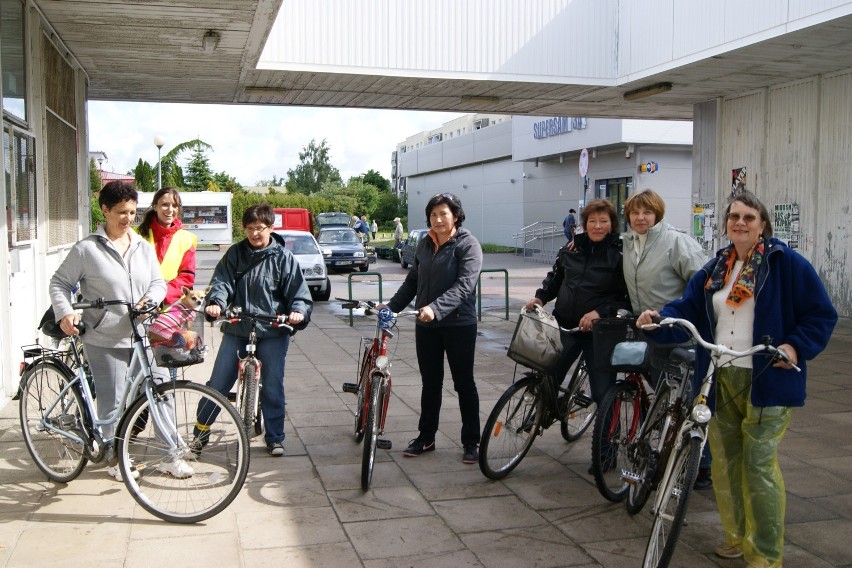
[338,298,420,491]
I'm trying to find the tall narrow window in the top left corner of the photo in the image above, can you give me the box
[0,0,27,124]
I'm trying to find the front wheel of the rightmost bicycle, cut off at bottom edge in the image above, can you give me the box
[642,434,701,568]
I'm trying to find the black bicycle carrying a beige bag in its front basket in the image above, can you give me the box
[479,308,596,480]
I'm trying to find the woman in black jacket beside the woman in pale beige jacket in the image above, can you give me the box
[524,199,630,403]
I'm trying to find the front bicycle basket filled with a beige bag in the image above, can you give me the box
[507,312,562,373]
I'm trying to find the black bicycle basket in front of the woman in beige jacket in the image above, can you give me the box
[592,318,650,373]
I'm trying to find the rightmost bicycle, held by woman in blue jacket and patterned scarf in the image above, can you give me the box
[642,318,800,568]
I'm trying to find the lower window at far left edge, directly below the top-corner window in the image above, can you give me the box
[3,125,38,249]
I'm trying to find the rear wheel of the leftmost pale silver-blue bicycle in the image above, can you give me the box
[18,361,88,483]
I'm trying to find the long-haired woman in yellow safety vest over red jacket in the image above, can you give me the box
[138,187,198,306]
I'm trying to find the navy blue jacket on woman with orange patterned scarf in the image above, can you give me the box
[654,238,837,406]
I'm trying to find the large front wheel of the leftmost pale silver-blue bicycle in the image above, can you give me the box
[117,381,249,523]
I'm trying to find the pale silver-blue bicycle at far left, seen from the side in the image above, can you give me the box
[19,298,249,523]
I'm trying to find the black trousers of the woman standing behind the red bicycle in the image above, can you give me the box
[414,324,480,445]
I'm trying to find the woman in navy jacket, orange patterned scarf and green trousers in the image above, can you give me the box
[637,192,837,568]
